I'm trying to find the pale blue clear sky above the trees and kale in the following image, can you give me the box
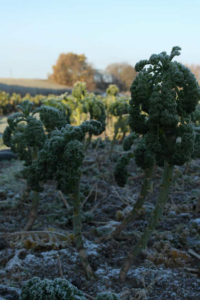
[0,0,200,78]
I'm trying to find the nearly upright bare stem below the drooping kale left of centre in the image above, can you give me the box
[73,175,93,279]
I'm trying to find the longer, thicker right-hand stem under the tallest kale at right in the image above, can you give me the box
[119,163,174,281]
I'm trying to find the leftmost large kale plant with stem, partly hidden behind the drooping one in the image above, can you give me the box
[3,100,60,230]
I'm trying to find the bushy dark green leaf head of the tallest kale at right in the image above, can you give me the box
[129,47,200,166]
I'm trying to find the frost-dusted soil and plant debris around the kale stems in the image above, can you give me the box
[0,145,200,300]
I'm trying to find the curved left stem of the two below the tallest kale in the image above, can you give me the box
[96,166,153,244]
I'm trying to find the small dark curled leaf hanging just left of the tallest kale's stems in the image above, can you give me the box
[114,153,133,187]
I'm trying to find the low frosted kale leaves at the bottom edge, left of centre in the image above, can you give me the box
[19,277,86,300]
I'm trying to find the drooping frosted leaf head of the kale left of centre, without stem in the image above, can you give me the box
[28,120,102,194]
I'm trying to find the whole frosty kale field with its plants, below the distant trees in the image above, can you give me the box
[0,47,200,300]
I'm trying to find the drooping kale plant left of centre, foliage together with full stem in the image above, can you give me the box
[28,120,102,278]
